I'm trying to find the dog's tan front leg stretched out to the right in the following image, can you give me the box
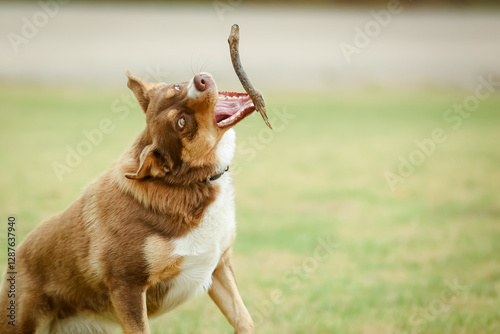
[208,252,254,334]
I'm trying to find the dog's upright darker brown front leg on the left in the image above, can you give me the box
[110,285,151,334]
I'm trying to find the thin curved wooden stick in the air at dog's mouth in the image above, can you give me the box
[227,24,273,130]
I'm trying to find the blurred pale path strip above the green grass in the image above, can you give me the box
[0,2,500,89]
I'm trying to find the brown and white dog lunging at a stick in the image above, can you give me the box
[0,73,254,334]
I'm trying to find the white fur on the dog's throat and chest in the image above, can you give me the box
[154,130,236,313]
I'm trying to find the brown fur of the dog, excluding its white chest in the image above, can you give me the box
[0,74,253,333]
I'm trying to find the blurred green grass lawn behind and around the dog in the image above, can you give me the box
[0,86,500,334]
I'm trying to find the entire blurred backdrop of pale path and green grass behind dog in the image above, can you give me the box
[0,0,500,334]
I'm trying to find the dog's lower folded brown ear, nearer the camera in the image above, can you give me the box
[125,145,170,180]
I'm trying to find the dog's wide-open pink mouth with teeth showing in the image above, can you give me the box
[214,92,255,128]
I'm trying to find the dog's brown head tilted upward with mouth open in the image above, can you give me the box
[125,72,255,179]
